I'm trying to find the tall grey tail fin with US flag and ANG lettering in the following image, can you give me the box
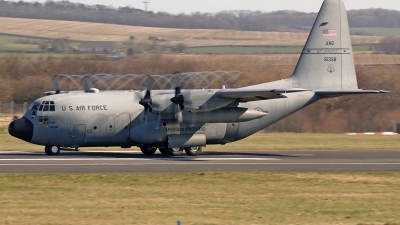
[291,0,358,90]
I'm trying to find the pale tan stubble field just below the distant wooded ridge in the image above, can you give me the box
[0,17,381,47]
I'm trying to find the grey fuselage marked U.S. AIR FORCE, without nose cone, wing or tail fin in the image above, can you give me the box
[20,80,319,147]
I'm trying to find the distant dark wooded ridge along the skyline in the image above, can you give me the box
[0,0,400,31]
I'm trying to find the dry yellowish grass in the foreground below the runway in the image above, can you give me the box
[0,172,400,225]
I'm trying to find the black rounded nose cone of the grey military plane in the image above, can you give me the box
[8,117,33,142]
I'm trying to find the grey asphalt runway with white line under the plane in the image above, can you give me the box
[0,151,400,174]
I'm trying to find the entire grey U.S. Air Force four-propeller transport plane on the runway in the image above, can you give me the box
[8,0,387,156]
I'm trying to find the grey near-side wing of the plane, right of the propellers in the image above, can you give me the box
[215,89,308,102]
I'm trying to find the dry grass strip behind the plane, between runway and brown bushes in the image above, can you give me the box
[0,133,400,151]
